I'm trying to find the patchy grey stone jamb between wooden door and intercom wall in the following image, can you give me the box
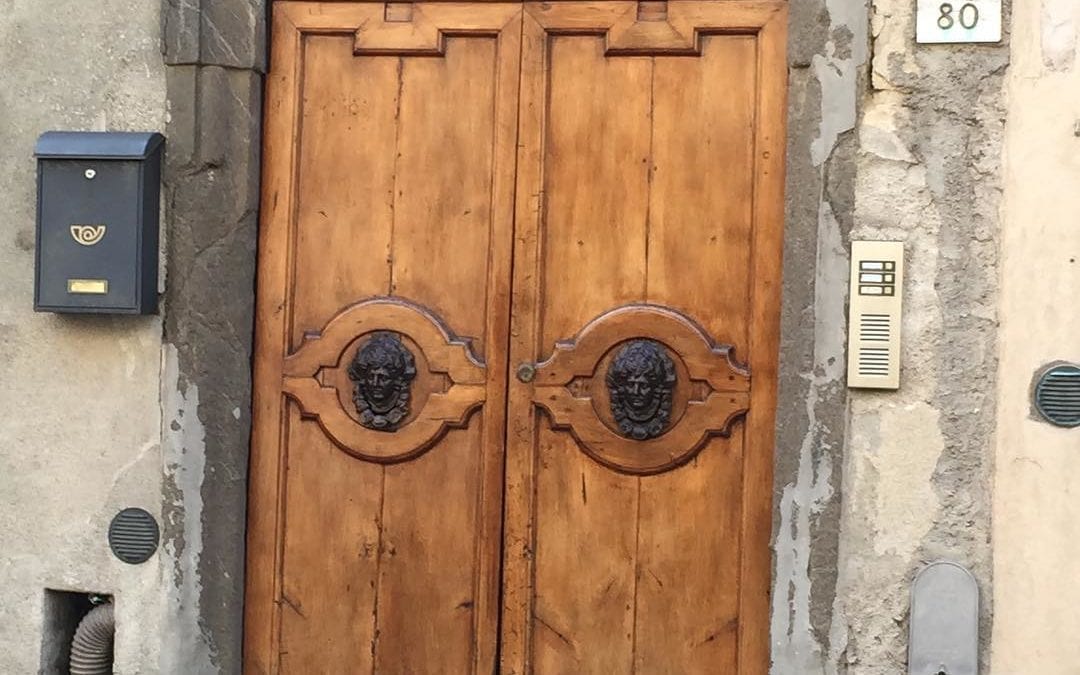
[771,0,868,675]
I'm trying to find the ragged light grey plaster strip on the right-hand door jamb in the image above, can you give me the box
[771,0,868,675]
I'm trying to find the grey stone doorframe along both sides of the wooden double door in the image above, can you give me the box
[156,0,866,673]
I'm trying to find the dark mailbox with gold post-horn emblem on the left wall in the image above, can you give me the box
[33,132,165,314]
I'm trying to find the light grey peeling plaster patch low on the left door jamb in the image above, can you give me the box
[161,345,217,673]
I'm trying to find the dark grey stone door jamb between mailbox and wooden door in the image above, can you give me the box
[161,0,267,673]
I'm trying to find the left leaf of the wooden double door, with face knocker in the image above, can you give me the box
[245,2,522,674]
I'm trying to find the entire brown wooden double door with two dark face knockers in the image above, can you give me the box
[245,0,786,675]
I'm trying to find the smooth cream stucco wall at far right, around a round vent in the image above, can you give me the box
[993,0,1080,675]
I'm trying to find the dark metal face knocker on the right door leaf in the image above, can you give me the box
[606,340,676,441]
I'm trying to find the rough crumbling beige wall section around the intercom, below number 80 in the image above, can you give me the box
[837,0,1009,675]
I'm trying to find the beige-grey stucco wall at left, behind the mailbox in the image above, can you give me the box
[0,0,165,673]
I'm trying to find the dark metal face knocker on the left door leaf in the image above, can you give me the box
[349,333,416,431]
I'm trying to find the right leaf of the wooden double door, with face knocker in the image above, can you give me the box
[502,0,786,674]
